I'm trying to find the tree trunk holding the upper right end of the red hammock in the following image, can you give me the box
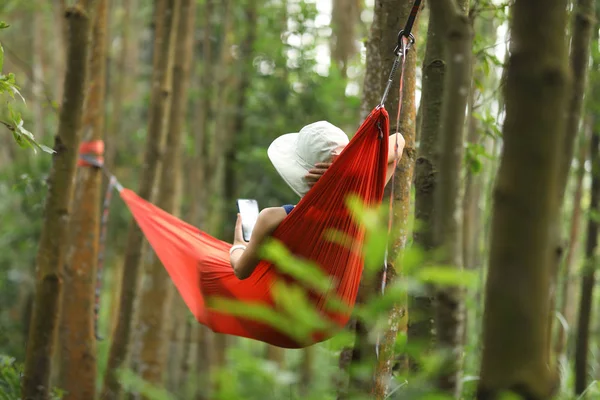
[351,0,417,399]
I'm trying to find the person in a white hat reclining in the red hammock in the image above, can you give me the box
[230,121,404,279]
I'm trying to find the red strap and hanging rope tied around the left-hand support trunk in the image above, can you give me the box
[77,145,123,340]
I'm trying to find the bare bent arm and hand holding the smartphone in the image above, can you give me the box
[229,207,287,279]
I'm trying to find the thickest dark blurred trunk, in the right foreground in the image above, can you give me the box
[478,0,570,400]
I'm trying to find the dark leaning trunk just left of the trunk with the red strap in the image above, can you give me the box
[23,6,91,400]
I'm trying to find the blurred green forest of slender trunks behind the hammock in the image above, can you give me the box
[0,0,600,399]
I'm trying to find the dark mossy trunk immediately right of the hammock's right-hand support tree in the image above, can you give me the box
[408,0,446,371]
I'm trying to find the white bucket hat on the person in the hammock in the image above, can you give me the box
[267,121,349,197]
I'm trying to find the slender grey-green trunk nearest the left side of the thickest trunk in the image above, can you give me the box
[431,0,472,397]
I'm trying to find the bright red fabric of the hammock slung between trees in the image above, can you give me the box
[121,106,389,348]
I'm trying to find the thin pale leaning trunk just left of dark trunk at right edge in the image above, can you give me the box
[555,123,593,360]
